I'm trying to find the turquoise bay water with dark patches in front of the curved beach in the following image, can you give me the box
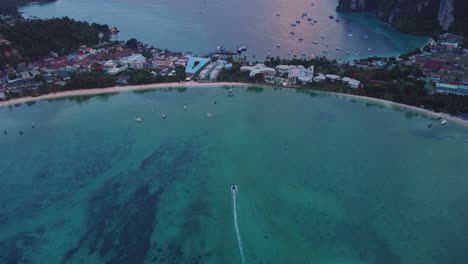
[0,85,468,264]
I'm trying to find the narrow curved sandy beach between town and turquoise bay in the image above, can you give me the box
[0,82,468,127]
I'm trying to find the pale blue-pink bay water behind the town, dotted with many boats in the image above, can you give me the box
[20,0,428,60]
